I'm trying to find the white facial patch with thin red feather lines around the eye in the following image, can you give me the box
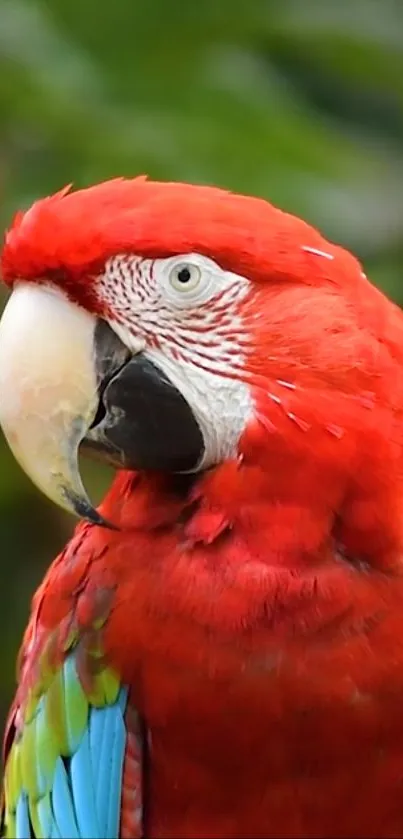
[98,254,253,468]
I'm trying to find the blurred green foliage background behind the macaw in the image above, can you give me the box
[0,0,403,726]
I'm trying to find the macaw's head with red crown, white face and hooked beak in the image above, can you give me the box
[0,178,403,568]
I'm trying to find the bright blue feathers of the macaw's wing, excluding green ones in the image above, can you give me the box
[6,654,132,839]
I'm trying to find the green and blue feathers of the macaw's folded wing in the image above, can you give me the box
[4,650,141,839]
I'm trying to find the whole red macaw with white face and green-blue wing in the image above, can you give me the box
[0,176,403,839]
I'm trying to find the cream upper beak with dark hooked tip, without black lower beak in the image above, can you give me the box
[0,283,130,524]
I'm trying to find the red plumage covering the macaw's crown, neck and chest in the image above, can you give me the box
[2,179,403,839]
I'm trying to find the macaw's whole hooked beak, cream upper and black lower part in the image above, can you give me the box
[0,283,203,525]
